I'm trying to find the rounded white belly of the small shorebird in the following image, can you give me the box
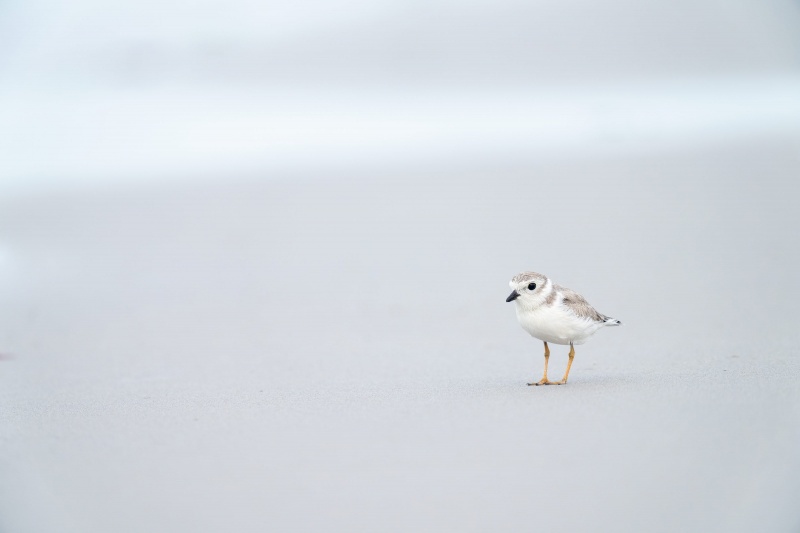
[517,306,603,344]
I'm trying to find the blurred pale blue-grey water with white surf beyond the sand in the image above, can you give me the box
[0,0,800,194]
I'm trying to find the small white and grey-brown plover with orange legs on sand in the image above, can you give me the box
[506,272,622,385]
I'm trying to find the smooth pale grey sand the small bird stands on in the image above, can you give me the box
[0,139,800,533]
